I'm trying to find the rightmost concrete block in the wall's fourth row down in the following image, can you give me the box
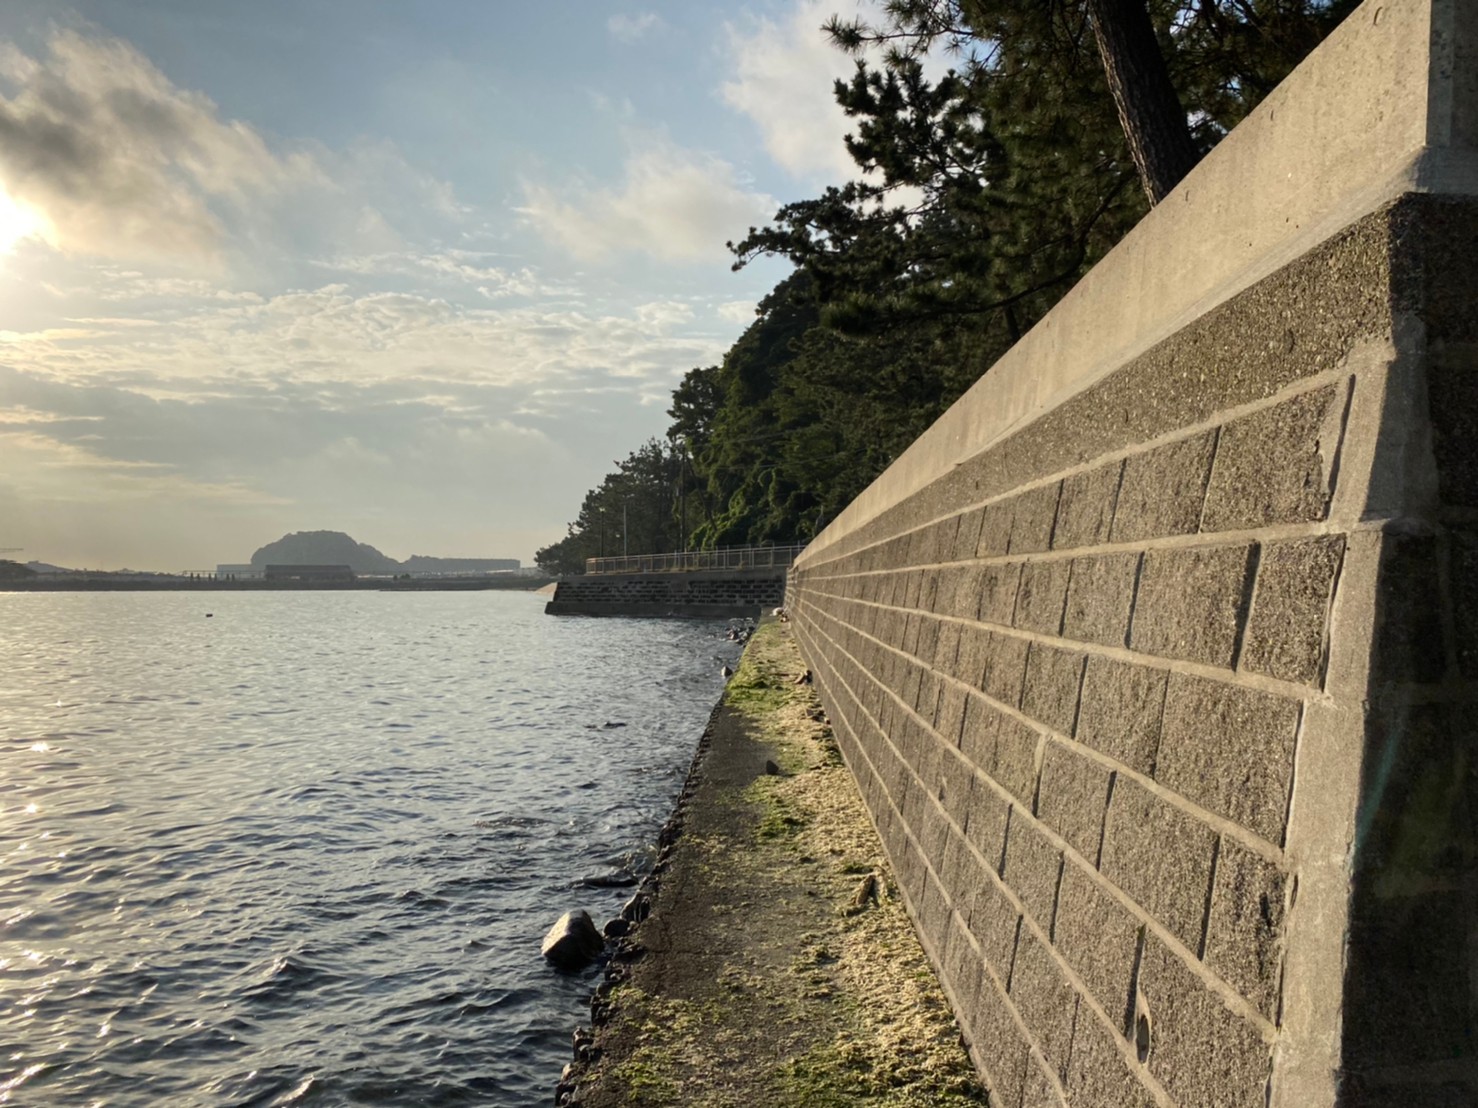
[1206,838,1287,1021]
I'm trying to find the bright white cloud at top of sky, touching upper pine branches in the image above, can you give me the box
[721,0,857,182]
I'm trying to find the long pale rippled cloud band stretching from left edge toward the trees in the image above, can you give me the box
[0,284,721,397]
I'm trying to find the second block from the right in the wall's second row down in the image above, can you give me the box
[1129,544,1252,668]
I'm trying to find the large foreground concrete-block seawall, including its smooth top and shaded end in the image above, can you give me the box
[788,0,1478,1108]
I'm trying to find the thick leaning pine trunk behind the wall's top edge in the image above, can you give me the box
[1088,0,1200,205]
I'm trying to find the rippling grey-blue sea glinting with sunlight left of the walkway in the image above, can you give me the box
[0,592,736,1108]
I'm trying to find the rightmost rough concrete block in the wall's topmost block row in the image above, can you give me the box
[1202,386,1344,532]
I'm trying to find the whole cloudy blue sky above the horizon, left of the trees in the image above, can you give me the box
[0,0,857,569]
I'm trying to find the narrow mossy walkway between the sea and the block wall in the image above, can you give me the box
[563,620,986,1108]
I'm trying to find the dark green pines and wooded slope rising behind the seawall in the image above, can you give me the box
[535,0,1355,573]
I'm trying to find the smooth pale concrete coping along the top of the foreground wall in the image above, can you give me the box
[797,0,1478,567]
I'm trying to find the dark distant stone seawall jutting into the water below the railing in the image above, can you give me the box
[544,566,786,619]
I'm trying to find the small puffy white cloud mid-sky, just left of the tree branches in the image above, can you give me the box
[520,140,777,261]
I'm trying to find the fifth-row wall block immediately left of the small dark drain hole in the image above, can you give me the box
[1052,863,1144,1031]
